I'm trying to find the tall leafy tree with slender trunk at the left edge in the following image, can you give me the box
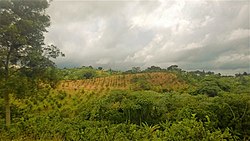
[0,0,62,127]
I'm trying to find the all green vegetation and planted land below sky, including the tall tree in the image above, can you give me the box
[0,0,250,141]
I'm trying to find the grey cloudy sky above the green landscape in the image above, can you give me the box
[45,0,250,74]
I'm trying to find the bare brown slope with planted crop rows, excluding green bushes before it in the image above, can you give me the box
[58,72,184,91]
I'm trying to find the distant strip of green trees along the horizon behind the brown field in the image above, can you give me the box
[58,65,250,80]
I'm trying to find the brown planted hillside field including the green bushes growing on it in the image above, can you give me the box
[57,72,187,93]
